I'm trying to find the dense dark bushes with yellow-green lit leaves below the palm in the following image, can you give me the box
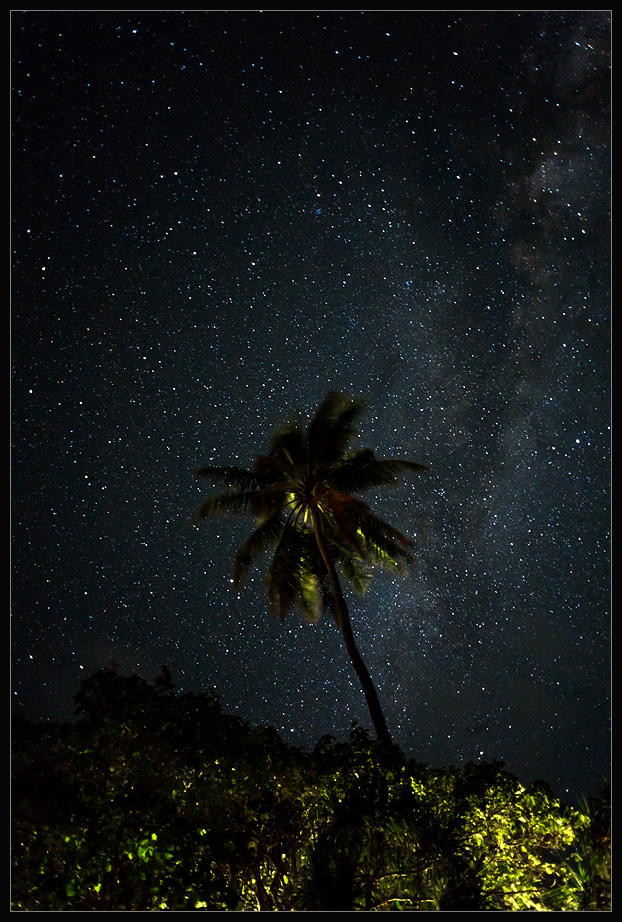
[12,669,610,912]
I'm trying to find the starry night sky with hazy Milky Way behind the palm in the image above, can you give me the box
[11,10,611,797]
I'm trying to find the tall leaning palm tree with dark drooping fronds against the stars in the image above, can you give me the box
[194,391,428,744]
